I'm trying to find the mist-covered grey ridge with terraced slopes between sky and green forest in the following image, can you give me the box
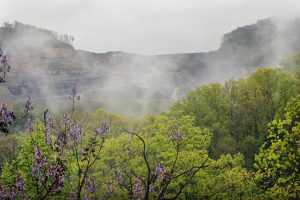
[0,19,300,116]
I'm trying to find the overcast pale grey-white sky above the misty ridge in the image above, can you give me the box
[0,0,300,54]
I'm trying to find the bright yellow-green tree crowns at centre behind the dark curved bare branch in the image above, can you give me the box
[96,113,210,199]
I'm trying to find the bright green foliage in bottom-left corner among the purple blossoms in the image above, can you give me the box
[1,122,72,199]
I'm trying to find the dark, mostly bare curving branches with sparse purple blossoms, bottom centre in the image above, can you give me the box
[121,127,208,200]
